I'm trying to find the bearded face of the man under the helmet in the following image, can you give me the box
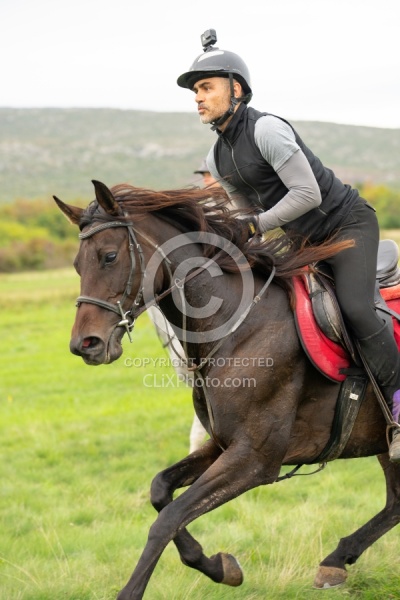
[193,77,231,128]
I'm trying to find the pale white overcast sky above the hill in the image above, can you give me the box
[0,0,400,128]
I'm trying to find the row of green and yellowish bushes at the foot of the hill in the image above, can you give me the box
[0,184,400,273]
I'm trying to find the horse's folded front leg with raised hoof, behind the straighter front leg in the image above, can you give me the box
[151,440,243,586]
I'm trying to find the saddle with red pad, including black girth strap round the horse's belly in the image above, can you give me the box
[293,240,400,463]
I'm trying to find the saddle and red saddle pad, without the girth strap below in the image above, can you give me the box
[293,240,400,382]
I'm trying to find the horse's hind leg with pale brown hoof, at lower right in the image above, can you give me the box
[314,454,400,588]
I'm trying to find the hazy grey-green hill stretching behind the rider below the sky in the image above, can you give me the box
[0,108,400,202]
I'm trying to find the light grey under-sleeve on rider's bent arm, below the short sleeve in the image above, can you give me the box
[258,149,322,233]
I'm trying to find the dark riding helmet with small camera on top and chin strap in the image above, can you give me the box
[177,29,252,126]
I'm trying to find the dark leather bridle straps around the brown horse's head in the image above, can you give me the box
[76,221,144,342]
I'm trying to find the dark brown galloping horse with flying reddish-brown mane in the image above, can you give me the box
[56,182,400,600]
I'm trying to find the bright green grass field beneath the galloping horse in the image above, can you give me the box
[0,269,400,600]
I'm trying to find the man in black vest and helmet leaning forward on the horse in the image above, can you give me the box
[177,29,400,462]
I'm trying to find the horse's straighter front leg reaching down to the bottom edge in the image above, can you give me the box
[118,444,282,600]
